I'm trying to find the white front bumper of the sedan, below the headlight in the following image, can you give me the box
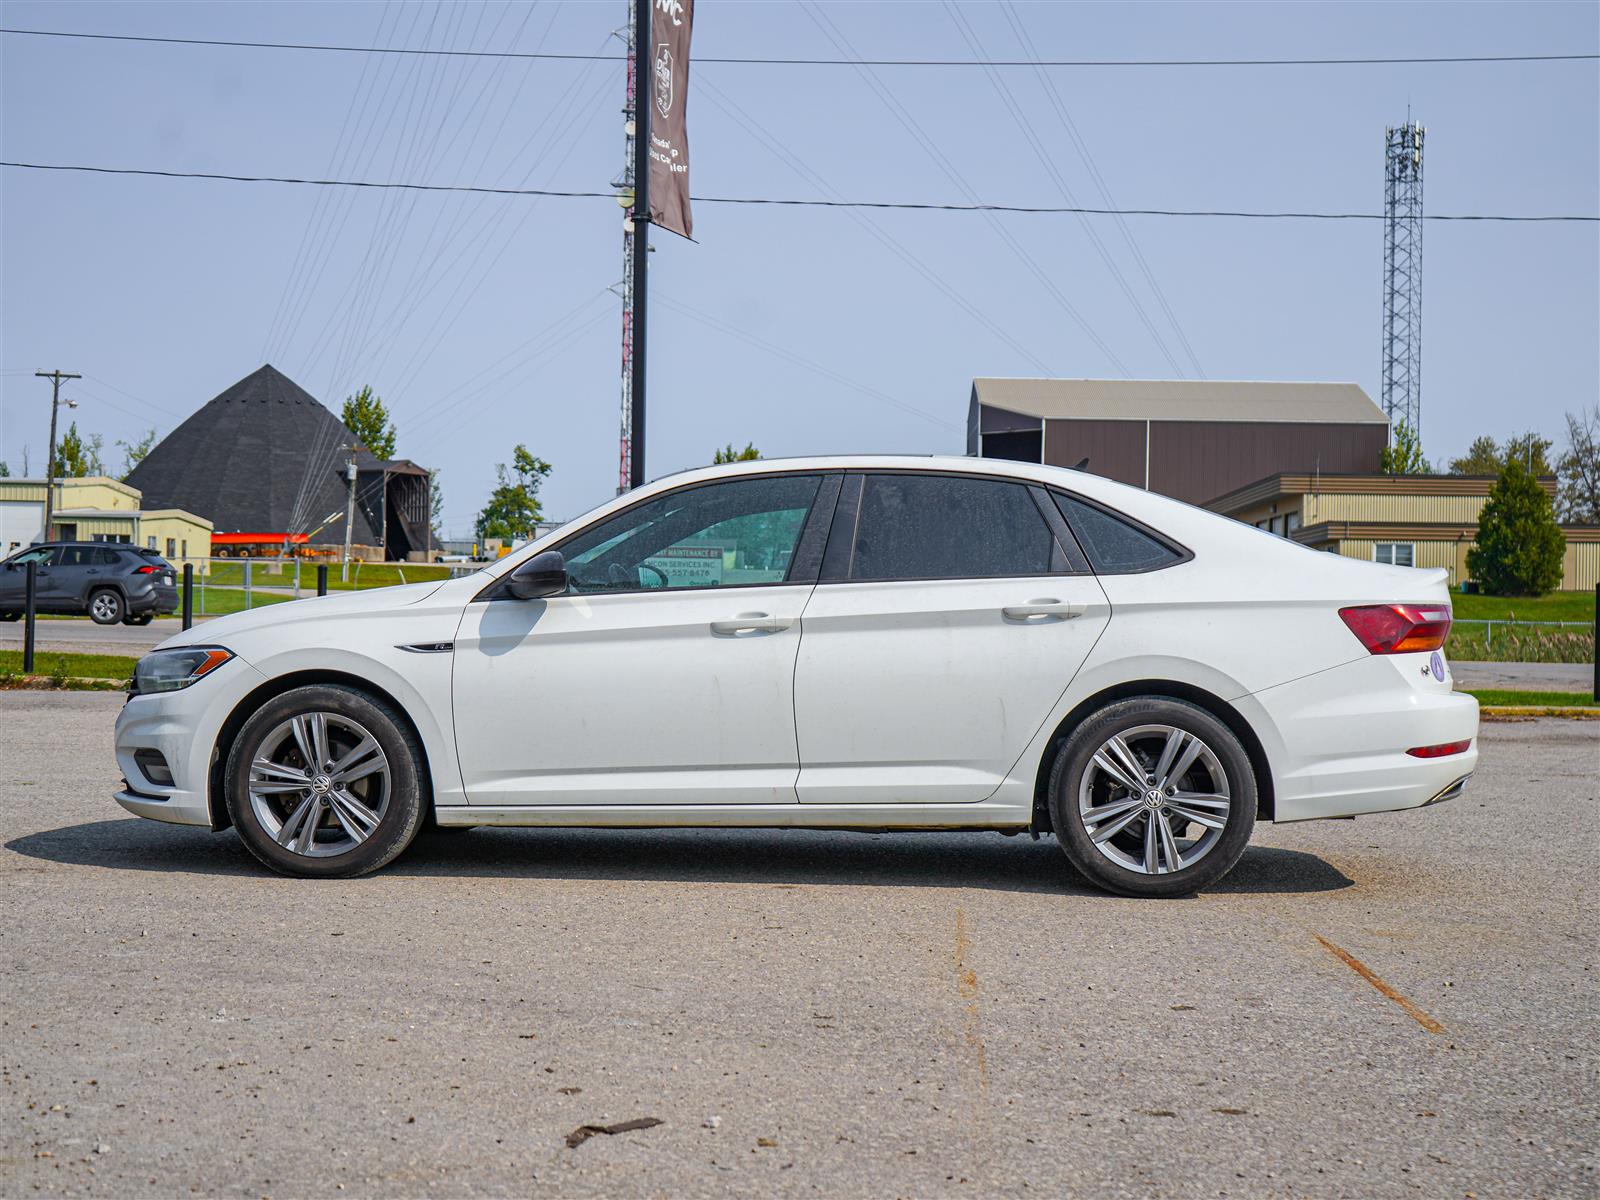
[114,658,266,827]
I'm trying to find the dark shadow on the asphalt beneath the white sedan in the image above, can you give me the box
[5,818,1352,894]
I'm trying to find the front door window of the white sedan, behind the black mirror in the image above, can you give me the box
[558,475,821,592]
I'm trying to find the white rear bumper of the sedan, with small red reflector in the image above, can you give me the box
[1237,654,1478,821]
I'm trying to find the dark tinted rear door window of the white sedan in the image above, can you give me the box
[850,475,1062,579]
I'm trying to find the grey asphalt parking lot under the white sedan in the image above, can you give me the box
[0,691,1600,1197]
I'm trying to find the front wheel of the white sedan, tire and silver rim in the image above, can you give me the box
[227,685,427,878]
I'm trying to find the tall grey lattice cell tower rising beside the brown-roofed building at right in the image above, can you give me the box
[1382,114,1427,435]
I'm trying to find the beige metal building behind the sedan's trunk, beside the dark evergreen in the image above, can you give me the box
[1205,472,1600,590]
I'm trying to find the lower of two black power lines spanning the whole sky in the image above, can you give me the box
[0,162,1600,222]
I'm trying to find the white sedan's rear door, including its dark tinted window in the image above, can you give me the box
[795,472,1110,803]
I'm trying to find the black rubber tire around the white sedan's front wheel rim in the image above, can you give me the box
[226,683,432,878]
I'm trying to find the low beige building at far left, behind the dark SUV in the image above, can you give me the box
[0,475,211,570]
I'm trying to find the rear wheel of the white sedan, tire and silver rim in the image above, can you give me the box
[1050,696,1256,898]
